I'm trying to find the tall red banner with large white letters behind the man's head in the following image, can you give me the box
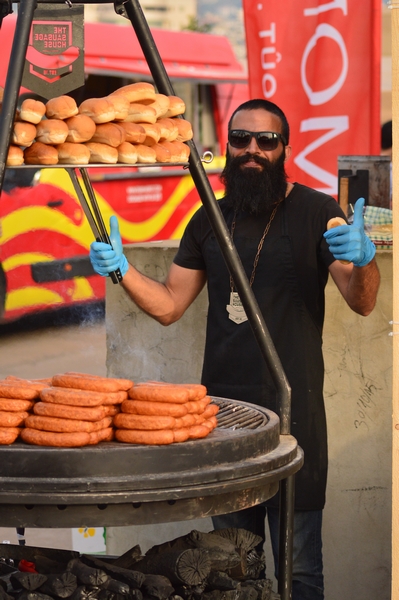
[243,0,382,196]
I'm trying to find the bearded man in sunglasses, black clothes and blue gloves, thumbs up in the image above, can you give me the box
[90,99,379,600]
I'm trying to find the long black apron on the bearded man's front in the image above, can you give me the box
[202,202,327,510]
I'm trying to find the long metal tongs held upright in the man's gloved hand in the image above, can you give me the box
[66,167,122,283]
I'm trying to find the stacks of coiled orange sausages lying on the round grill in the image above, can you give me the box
[0,372,219,448]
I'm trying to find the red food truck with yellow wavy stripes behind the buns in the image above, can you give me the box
[0,15,248,323]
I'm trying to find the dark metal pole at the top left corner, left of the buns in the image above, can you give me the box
[0,0,36,193]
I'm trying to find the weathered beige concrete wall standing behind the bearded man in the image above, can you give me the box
[106,242,392,600]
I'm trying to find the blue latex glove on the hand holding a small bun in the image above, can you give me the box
[324,198,375,267]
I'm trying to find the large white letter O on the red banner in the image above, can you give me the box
[301,23,348,106]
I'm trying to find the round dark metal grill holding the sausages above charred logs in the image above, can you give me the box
[0,398,303,527]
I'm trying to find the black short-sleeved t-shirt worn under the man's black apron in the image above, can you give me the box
[174,184,344,331]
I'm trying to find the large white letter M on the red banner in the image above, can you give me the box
[294,115,349,194]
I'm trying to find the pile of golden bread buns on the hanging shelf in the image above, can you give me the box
[3,82,193,166]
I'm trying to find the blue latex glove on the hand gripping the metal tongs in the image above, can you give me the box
[90,216,129,277]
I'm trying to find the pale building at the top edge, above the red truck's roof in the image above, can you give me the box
[85,0,197,31]
